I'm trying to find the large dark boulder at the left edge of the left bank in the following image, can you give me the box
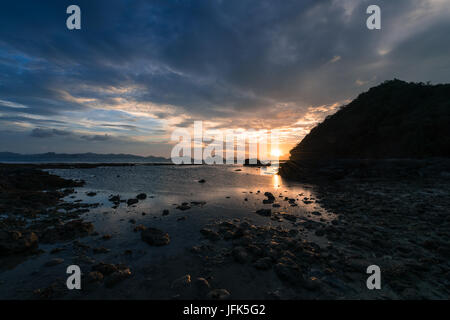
[0,231,38,256]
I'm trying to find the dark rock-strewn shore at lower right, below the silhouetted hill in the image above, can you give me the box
[167,172,450,299]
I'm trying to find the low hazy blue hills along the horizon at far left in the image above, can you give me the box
[0,152,171,163]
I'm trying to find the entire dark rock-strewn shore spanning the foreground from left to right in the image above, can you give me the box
[0,166,450,299]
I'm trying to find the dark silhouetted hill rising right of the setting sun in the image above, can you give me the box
[280,79,450,179]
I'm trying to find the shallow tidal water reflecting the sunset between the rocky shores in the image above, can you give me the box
[0,165,334,298]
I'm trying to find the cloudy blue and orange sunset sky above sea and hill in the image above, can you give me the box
[0,0,450,157]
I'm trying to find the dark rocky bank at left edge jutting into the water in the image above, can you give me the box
[0,166,93,262]
